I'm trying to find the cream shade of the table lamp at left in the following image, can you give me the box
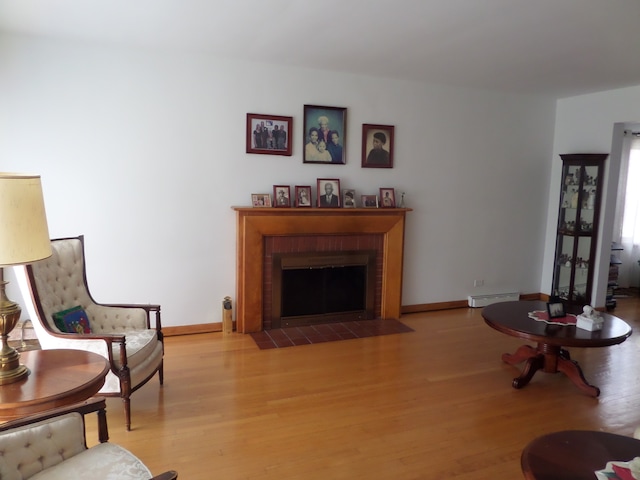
[0,172,51,267]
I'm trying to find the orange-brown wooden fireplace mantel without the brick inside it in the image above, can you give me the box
[232,207,411,333]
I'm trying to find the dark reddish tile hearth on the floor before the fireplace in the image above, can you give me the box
[250,319,414,350]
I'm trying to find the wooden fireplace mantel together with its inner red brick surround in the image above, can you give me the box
[233,207,411,333]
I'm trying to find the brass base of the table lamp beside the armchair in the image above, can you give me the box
[0,281,29,385]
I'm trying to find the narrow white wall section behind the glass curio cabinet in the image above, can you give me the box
[540,86,640,306]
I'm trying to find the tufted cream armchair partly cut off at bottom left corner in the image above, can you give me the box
[0,398,178,480]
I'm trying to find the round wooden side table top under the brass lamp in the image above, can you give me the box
[0,349,109,421]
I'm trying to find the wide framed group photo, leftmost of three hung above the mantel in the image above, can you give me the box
[247,113,293,156]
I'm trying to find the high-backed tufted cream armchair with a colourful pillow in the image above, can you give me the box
[25,236,164,430]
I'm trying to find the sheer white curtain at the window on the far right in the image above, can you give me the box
[619,136,640,287]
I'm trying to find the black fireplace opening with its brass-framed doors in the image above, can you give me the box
[264,250,376,328]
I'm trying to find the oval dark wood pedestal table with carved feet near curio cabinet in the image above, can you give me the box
[482,301,631,397]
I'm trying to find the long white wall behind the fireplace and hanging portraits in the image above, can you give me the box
[0,32,555,326]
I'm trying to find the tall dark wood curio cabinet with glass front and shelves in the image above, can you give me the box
[552,153,608,307]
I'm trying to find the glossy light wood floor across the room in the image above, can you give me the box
[91,299,640,480]
